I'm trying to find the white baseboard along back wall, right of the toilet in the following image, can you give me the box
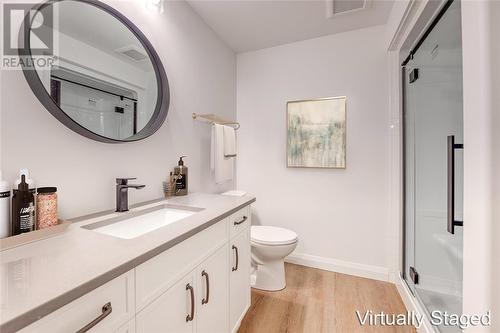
[285,253,389,281]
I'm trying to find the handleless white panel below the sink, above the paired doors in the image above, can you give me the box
[135,219,227,311]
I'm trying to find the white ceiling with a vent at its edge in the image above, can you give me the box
[187,0,394,52]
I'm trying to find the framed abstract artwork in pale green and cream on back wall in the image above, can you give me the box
[286,96,346,169]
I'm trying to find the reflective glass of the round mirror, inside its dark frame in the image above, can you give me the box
[30,0,158,140]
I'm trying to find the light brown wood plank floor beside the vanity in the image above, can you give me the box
[238,264,415,333]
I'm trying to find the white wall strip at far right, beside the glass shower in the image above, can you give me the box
[462,1,500,332]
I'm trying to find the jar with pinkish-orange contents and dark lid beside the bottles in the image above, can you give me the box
[36,187,57,229]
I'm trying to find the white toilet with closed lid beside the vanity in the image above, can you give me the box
[250,226,298,291]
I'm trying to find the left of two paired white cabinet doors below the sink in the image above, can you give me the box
[136,272,197,333]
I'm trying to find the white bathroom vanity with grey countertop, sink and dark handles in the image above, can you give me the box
[0,193,255,333]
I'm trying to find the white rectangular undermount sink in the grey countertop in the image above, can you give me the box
[82,204,203,239]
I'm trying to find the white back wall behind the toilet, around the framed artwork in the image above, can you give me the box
[237,26,390,279]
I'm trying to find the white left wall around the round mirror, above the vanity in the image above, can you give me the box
[0,0,236,218]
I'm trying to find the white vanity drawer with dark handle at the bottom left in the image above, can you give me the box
[19,270,135,333]
